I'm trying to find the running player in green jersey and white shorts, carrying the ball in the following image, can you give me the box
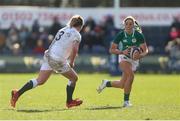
[97,16,148,107]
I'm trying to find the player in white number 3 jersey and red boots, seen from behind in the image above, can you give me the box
[11,15,84,108]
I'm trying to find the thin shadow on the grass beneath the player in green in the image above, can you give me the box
[86,106,123,110]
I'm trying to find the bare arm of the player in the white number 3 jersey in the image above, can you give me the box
[69,41,79,67]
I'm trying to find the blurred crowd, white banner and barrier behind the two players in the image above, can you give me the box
[0,0,180,75]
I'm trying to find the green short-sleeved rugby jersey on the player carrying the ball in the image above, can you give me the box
[113,30,145,50]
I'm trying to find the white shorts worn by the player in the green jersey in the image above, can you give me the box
[119,55,139,71]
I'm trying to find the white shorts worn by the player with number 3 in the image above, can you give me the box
[40,52,71,73]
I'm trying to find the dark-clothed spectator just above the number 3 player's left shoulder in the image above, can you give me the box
[49,16,62,37]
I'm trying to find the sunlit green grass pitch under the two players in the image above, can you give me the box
[0,73,180,120]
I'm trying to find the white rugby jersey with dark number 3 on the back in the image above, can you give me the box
[48,26,81,61]
